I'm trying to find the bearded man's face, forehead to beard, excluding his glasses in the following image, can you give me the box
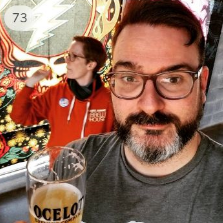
[112,24,207,163]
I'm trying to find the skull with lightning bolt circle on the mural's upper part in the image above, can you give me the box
[0,0,120,92]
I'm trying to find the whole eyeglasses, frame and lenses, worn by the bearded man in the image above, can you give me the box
[105,68,202,100]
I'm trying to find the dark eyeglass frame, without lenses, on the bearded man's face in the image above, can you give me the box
[104,66,202,100]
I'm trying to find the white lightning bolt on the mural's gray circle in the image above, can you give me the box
[26,0,74,52]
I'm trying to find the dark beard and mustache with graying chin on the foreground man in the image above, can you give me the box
[115,100,203,164]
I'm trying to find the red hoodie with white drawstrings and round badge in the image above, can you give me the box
[11,83,114,146]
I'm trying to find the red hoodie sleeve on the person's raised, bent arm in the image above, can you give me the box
[10,86,48,125]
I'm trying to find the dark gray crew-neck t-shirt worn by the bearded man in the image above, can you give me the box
[69,132,223,223]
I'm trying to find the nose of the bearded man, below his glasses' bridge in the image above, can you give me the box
[138,80,165,115]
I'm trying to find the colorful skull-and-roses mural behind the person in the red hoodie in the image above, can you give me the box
[0,0,121,168]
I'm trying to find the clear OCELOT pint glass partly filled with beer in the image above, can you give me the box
[26,146,86,223]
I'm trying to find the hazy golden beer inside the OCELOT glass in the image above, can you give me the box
[30,183,84,223]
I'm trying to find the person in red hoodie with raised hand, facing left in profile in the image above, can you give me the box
[11,36,113,146]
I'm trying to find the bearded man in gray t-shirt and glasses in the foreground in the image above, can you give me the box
[15,0,223,223]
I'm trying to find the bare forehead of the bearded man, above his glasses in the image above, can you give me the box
[113,24,199,70]
